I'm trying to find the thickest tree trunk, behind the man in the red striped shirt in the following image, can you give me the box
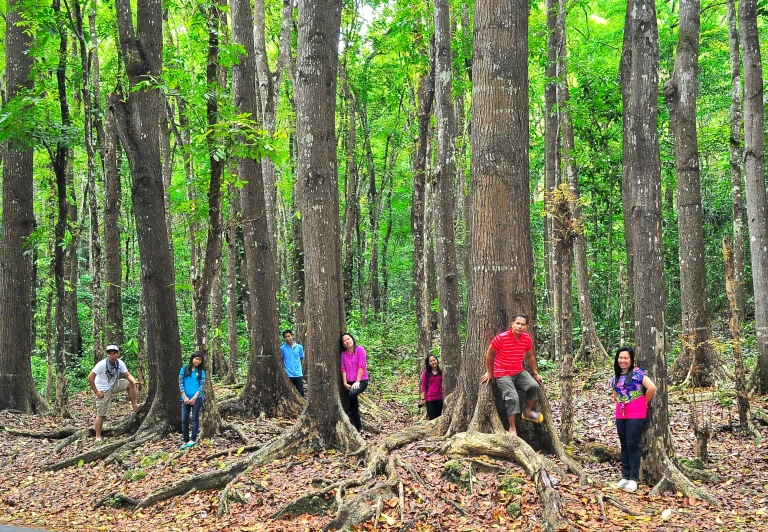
[443,0,534,440]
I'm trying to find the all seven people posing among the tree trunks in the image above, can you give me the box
[88,314,656,492]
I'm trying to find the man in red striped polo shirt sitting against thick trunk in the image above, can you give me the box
[480,314,544,436]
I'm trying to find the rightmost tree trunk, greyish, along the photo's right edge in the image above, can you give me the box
[739,0,768,395]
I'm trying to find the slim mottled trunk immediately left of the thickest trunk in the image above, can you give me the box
[434,0,461,394]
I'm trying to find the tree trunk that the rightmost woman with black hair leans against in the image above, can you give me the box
[620,0,672,484]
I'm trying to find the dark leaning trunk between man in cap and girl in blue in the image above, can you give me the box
[110,0,181,432]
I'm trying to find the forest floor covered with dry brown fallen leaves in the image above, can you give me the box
[0,366,768,532]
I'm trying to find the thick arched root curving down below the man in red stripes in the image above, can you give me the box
[443,432,570,530]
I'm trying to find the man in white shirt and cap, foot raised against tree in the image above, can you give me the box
[88,345,139,441]
